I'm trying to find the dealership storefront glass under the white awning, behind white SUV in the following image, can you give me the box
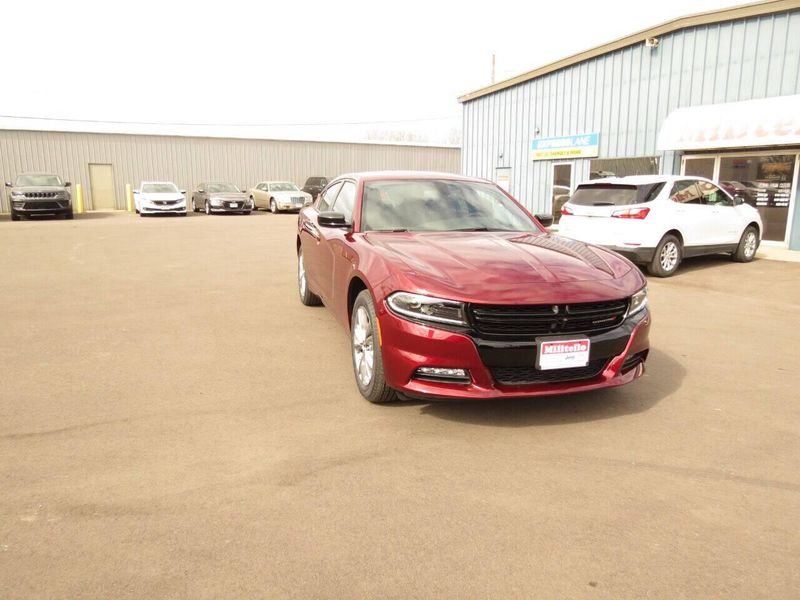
[683,151,800,243]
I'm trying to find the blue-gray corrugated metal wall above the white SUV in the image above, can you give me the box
[461,11,800,212]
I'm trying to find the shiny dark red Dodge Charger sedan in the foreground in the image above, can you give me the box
[297,172,650,402]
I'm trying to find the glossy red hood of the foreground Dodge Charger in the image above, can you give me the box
[364,232,644,303]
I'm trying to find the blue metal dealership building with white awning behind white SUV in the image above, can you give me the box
[459,0,800,249]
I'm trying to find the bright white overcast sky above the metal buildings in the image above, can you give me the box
[0,0,741,142]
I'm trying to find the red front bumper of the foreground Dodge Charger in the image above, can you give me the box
[378,306,651,400]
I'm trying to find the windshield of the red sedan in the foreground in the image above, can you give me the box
[361,180,539,232]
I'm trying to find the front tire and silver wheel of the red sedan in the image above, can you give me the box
[350,290,397,404]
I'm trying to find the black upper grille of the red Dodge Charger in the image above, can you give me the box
[468,299,628,337]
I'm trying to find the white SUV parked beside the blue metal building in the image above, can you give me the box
[559,175,764,277]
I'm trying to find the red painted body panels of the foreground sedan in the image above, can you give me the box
[297,172,650,399]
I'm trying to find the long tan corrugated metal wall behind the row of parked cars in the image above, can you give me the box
[0,130,461,212]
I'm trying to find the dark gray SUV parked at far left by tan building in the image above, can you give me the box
[6,173,72,221]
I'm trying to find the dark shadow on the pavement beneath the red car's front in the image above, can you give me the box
[412,349,686,427]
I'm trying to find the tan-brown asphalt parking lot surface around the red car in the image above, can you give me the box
[0,213,800,599]
